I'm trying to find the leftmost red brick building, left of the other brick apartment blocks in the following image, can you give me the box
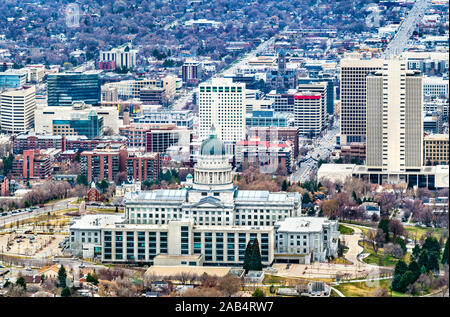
[12,150,51,179]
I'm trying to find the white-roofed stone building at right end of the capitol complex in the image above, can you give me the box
[275,217,339,264]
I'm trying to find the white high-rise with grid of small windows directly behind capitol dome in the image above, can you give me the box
[199,78,246,153]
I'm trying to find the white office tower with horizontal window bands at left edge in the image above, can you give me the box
[0,86,36,134]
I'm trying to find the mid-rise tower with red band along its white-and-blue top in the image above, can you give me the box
[294,91,324,137]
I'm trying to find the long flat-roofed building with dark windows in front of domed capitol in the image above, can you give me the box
[102,218,274,266]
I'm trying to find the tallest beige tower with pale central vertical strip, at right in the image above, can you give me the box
[366,59,423,172]
